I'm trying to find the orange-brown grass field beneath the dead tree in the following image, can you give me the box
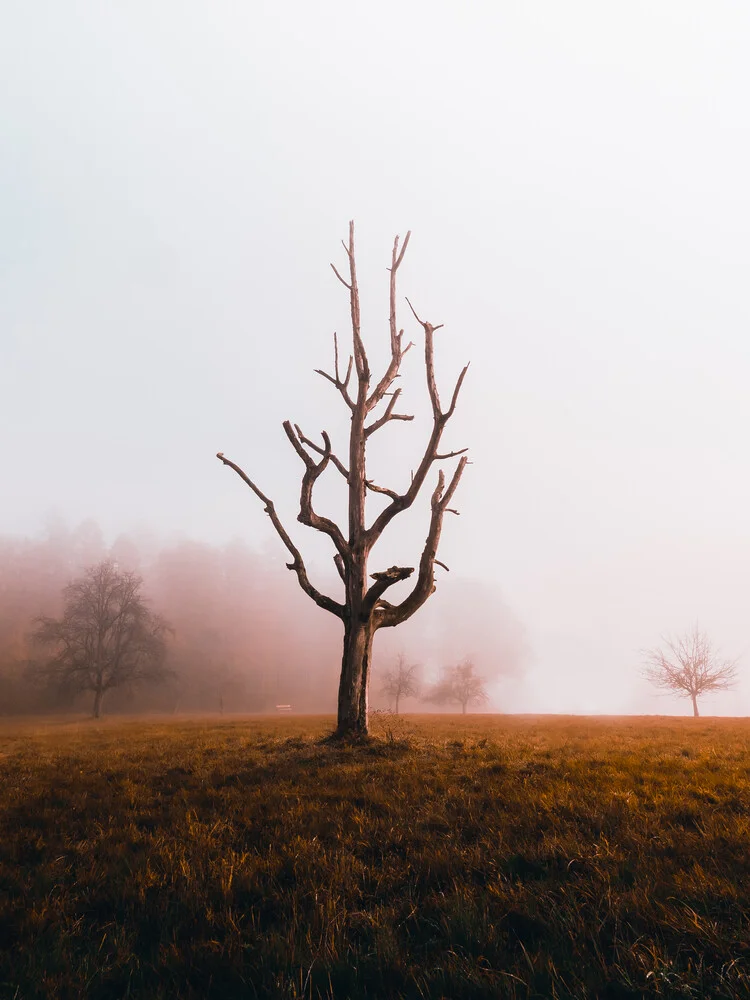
[0,716,750,1000]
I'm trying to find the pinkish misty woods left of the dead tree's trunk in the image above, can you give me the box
[0,522,344,714]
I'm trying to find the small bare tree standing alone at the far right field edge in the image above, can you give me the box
[643,625,737,718]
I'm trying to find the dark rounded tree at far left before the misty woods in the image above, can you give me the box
[31,560,169,719]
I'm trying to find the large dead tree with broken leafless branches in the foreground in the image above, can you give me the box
[217,222,468,737]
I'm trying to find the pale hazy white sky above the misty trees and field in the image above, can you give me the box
[0,0,750,714]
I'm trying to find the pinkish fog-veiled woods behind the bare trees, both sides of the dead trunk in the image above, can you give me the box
[0,521,528,715]
